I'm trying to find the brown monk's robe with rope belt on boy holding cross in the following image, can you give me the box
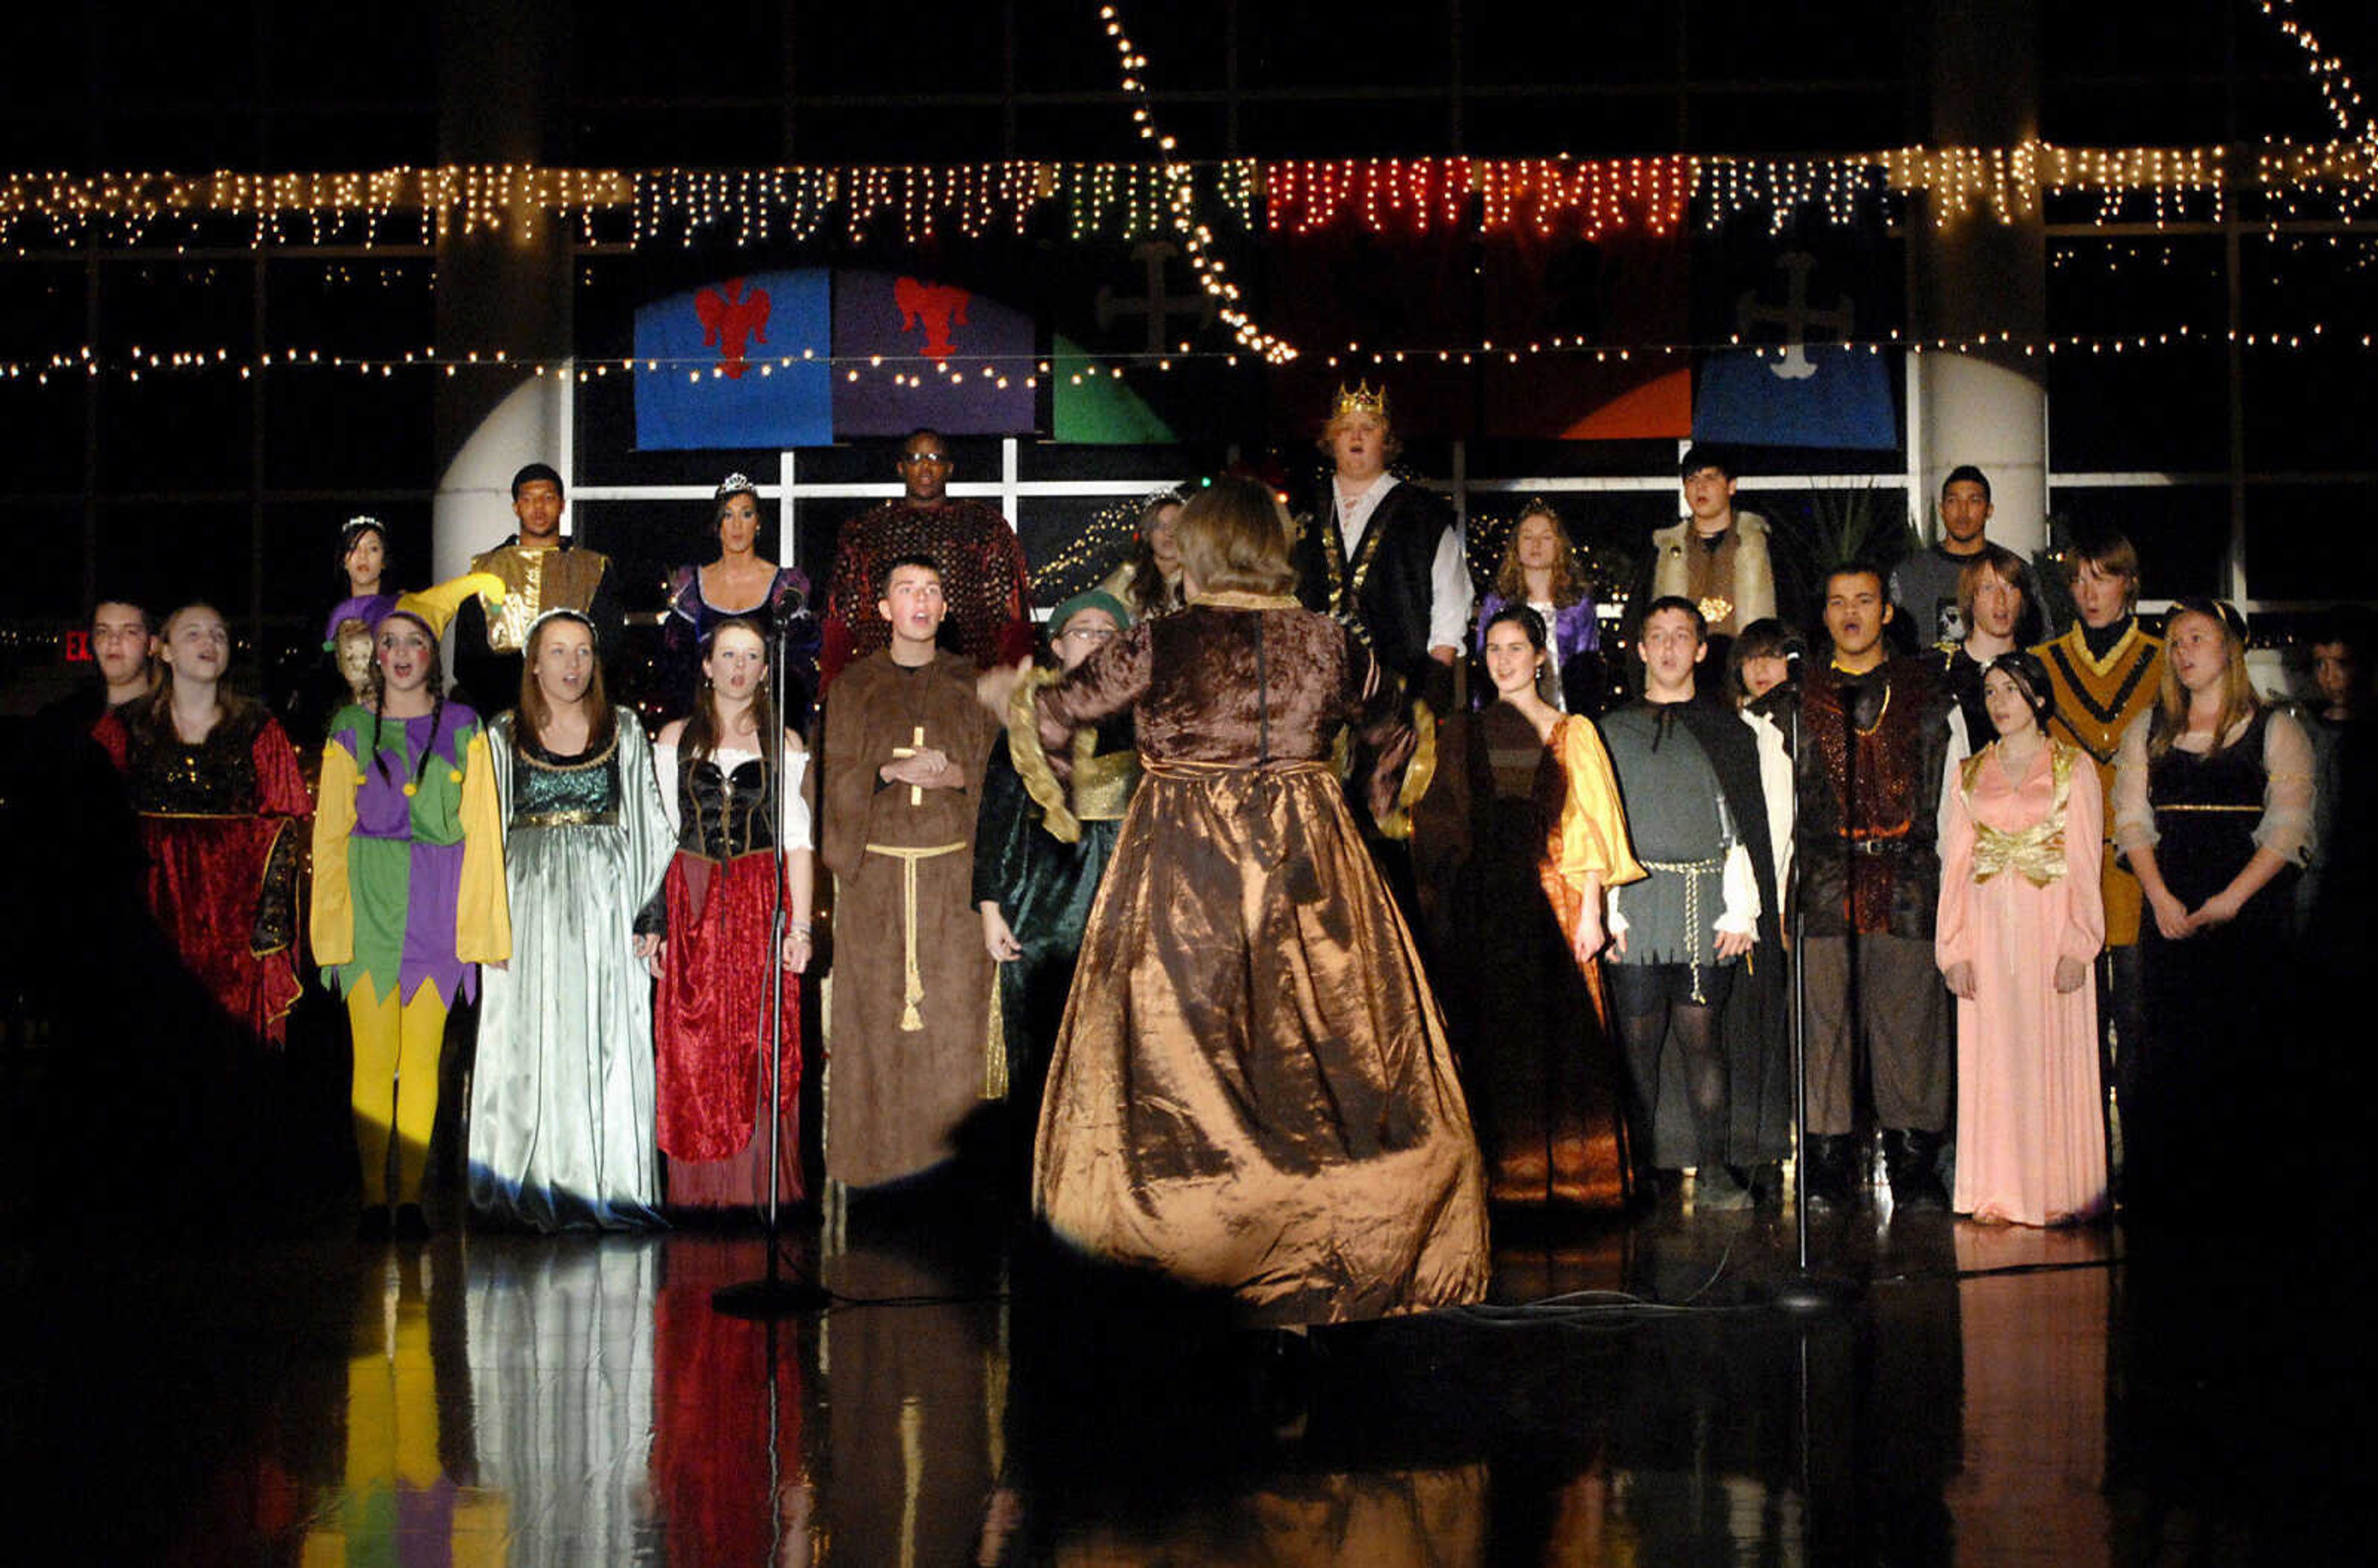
[818,650,996,1187]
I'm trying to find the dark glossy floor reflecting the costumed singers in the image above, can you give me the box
[0,1209,2371,1568]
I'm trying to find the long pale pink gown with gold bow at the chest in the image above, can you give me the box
[1936,740,2104,1226]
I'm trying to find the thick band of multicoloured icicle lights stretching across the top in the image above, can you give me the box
[0,141,2378,251]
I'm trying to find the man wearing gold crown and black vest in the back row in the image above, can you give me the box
[1289,383,1470,714]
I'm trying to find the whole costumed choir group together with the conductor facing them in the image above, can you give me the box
[51,388,2369,1325]
